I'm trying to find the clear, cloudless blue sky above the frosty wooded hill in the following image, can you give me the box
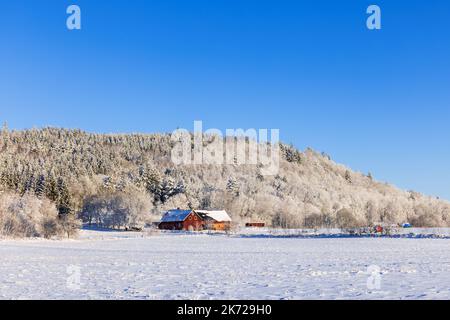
[0,0,450,199]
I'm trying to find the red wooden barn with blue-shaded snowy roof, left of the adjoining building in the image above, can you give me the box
[158,209,203,231]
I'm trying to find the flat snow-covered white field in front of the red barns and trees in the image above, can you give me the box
[0,231,450,299]
